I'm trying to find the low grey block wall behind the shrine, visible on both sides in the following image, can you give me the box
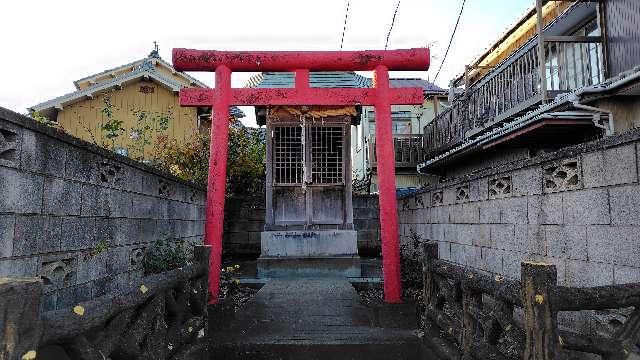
[223,195,380,257]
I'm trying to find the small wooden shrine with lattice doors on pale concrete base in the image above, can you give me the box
[257,106,360,276]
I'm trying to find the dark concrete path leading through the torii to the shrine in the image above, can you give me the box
[211,278,430,360]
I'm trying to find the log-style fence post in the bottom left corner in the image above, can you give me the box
[0,278,42,360]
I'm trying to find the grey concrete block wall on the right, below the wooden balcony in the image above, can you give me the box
[398,131,640,286]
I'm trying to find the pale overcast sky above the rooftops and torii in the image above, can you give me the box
[0,0,534,125]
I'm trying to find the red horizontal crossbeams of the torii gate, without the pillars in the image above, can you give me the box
[173,48,429,106]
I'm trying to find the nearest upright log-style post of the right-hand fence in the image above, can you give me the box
[520,262,559,360]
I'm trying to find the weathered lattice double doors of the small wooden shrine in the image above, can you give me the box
[266,107,355,230]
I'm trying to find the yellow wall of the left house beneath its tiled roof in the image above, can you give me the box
[57,81,198,158]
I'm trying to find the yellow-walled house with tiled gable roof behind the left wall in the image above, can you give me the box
[28,49,244,155]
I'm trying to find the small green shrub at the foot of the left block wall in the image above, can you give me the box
[143,235,189,274]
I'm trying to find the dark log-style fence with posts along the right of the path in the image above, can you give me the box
[423,242,640,360]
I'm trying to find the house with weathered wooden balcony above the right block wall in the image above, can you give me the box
[418,0,640,179]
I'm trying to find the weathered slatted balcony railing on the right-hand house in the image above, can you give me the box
[424,36,603,158]
